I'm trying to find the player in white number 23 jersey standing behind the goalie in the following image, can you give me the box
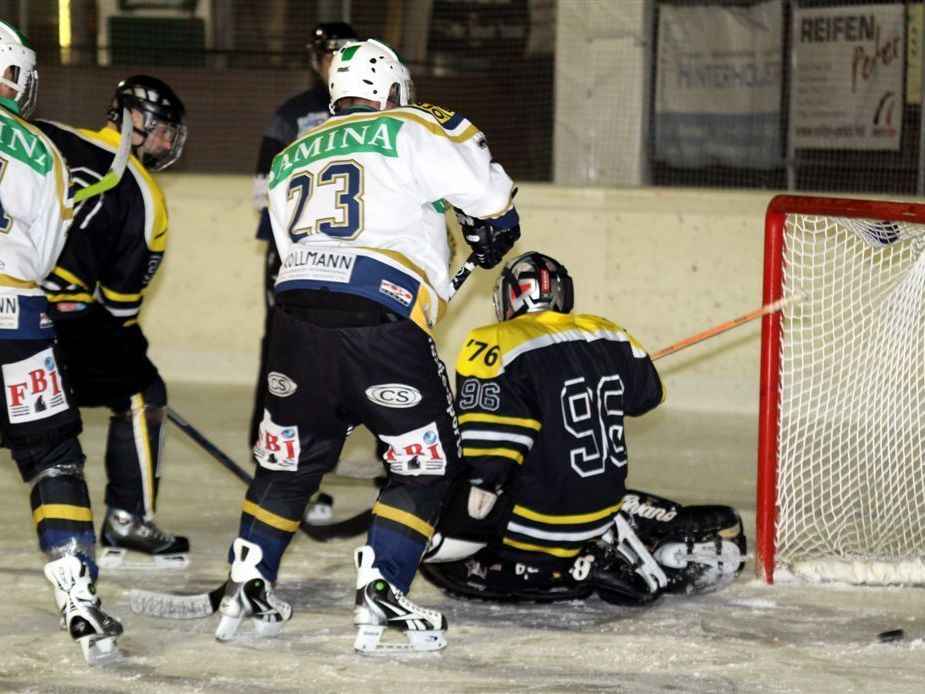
[217,40,520,652]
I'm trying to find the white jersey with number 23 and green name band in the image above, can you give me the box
[268,104,516,338]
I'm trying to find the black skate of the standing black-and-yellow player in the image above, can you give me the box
[98,509,189,569]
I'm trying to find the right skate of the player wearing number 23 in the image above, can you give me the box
[353,546,447,654]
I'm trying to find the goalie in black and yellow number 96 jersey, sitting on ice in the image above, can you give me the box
[421,252,745,605]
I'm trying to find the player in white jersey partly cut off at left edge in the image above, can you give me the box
[0,21,122,664]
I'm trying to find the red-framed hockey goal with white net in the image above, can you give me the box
[756,196,925,584]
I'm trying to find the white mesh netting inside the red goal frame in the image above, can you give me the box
[777,214,925,582]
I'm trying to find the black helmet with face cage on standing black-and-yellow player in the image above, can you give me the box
[106,75,186,171]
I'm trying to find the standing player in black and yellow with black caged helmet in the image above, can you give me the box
[38,75,189,566]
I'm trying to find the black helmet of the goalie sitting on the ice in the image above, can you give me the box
[492,251,573,321]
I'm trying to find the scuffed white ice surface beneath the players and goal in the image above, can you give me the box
[0,385,925,694]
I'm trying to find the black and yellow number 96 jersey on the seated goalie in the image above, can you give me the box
[456,311,663,556]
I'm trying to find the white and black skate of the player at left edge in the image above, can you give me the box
[45,554,122,665]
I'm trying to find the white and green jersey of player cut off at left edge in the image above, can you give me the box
[0,99,74,340]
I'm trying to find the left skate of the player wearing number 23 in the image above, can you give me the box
[215,537,292,641]
